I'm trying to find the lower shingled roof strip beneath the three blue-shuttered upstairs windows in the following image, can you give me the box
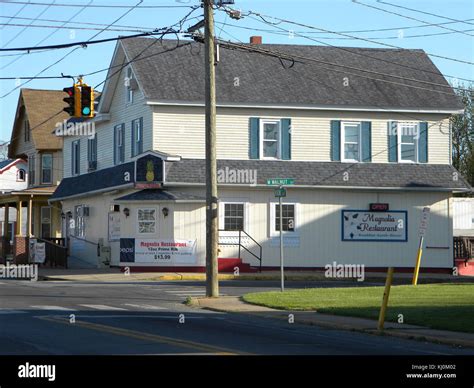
[166,159,471,191]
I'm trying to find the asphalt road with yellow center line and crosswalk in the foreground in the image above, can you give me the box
[0,280,474,355]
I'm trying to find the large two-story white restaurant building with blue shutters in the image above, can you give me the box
[50,38,471,271]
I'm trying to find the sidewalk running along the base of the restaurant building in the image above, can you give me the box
[39,267,474,285]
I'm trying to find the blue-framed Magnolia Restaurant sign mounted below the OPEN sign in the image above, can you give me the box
[342,210,408,241]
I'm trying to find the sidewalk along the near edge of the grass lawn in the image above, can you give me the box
[191,296,474,347]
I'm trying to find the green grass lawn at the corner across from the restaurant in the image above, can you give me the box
[243,284,474,333]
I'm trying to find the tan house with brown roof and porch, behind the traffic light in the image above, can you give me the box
[0,89,68,261]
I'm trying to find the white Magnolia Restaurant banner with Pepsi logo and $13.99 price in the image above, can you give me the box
[120,238,197,266]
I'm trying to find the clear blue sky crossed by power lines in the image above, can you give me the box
[0,0,474,140]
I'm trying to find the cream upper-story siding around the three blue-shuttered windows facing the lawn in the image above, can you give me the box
[153,105,450,164]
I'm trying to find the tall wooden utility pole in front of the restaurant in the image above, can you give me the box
[203,0,219,298]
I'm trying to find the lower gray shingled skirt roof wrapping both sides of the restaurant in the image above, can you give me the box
[50,159,471,201]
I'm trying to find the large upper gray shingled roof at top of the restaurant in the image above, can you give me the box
[121,38,463,110]
